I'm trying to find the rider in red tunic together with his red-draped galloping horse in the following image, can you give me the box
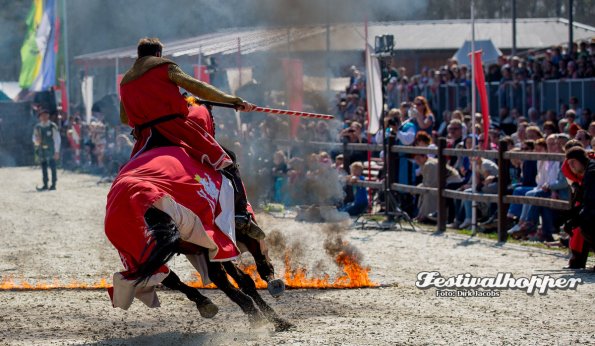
[106,38,292,325]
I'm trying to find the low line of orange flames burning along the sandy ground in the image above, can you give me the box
[0,245,378,291]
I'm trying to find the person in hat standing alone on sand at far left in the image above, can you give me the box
[33,109,61,191]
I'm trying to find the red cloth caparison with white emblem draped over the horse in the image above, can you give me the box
[105,146,239,274]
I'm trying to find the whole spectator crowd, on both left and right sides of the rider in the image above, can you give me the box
[42,41,595,246]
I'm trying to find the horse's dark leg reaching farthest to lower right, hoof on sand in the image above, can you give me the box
[223,262,295,332]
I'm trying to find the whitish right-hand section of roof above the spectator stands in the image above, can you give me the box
[292,18,595,51]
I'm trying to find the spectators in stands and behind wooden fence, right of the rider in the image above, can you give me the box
[234,41,595,247]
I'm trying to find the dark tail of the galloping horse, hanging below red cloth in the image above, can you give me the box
[131,207,180,285]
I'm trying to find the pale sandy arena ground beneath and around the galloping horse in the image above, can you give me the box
[0,168,595,345]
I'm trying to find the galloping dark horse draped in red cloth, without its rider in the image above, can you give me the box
[105,142,294,331]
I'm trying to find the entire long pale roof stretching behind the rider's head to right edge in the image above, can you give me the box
[75,18,595,63]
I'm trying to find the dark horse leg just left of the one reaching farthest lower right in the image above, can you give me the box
[207,262,264,328]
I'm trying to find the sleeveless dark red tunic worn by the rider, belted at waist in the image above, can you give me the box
[120,64,231,169]
